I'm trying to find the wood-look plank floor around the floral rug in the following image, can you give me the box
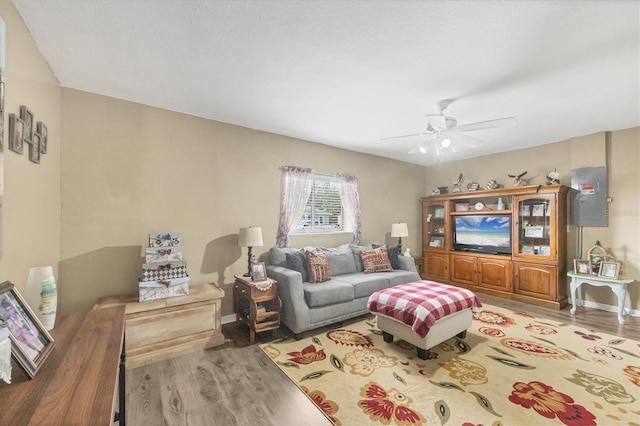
[126,294,640,426]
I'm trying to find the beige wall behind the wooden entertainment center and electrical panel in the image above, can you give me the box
[425,127,640,310]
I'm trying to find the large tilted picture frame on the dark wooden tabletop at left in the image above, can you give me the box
[0,281,55,378]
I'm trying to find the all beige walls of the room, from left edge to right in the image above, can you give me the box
[0,0,640,315]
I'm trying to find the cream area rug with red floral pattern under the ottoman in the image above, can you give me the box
[260,304,640,426]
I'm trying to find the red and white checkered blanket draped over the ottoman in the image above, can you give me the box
[367,280,482,338]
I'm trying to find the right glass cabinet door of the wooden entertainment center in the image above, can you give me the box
[514,196,556,258]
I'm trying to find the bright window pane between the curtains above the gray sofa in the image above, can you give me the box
[291,175,353,234]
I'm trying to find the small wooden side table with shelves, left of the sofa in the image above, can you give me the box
[233,275,282,344]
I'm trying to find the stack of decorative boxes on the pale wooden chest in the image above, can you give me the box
[139,233,189,302]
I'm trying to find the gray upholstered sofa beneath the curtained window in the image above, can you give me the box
[262,244,420,339]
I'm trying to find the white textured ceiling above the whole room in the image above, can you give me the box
[7,0,640,166]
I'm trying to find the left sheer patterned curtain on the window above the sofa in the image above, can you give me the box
[276,166,314,247]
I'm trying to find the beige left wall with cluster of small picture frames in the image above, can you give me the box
[0,0,62,295]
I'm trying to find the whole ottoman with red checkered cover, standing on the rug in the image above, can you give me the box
[367,280,482,359]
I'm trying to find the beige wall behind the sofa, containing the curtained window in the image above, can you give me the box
[60,89,425,315]
